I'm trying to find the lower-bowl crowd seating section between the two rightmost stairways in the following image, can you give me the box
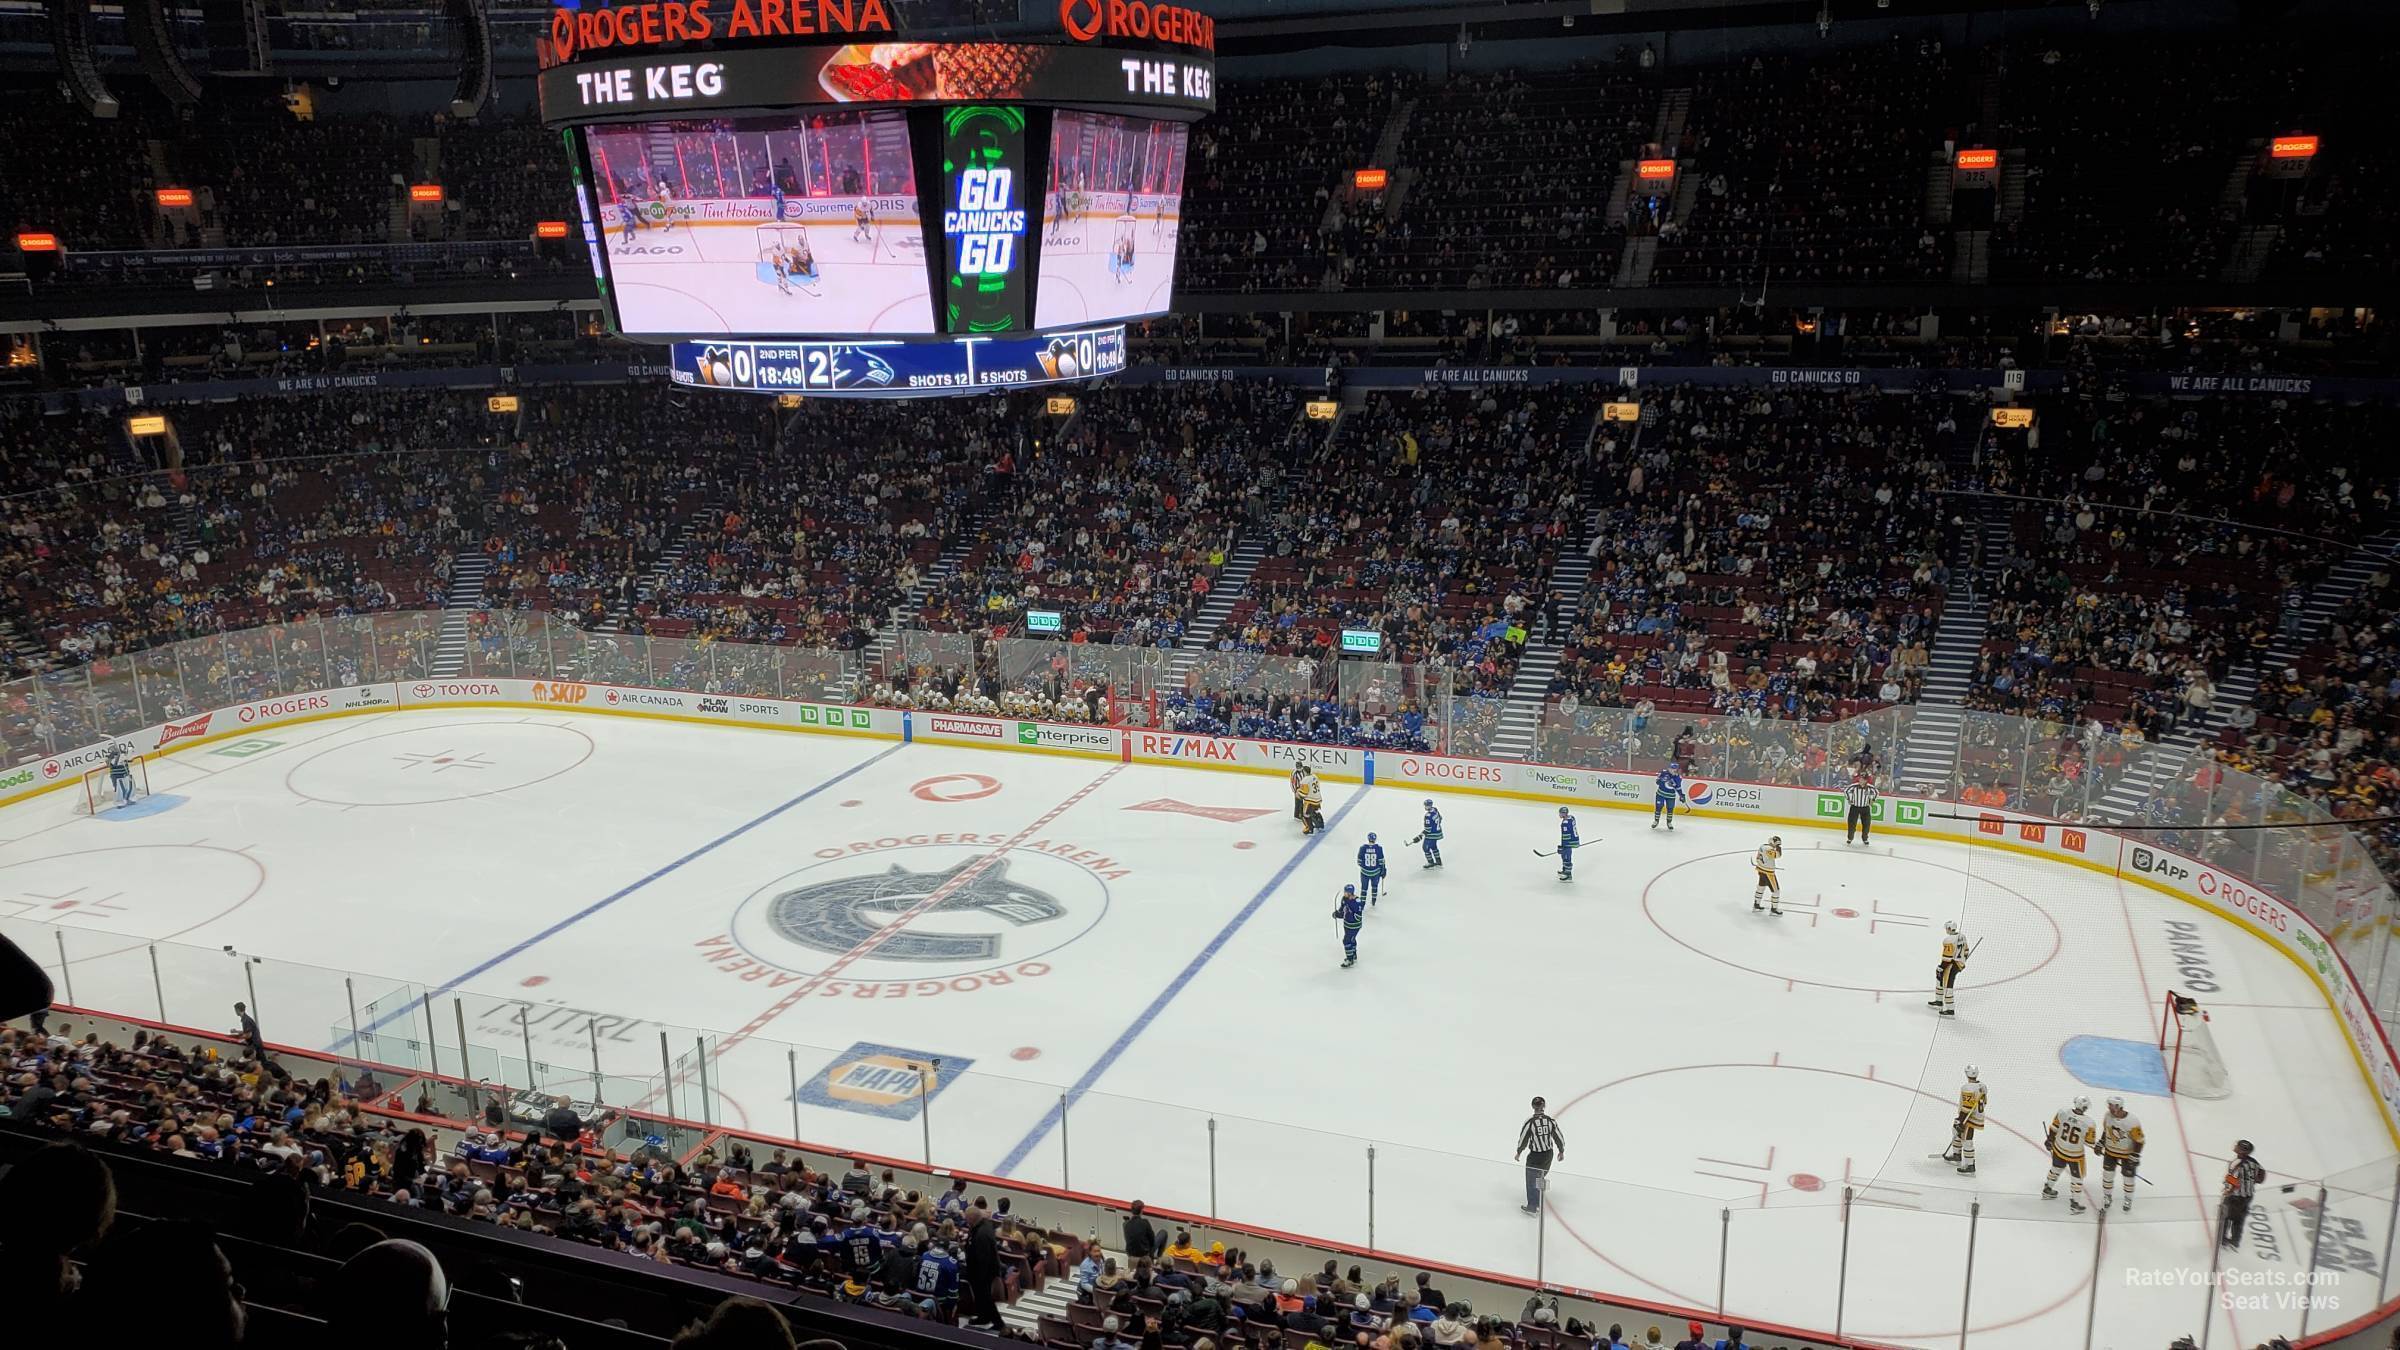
[1968,396,2390,740]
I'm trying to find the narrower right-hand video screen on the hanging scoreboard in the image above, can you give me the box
[1034,110,1188,329]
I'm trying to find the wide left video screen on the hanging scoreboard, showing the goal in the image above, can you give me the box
[583,110,936,336]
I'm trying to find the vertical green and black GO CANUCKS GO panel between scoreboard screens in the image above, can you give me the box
[941,106,1032,334]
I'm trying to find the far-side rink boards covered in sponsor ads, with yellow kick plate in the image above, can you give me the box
[18,677,2400,1146]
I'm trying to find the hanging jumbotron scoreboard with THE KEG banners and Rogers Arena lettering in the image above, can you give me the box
[540,0,1217,396]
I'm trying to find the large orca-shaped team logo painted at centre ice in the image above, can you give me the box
[766,858,1066,961]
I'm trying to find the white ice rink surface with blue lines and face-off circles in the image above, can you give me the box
[0,711,2393,1348]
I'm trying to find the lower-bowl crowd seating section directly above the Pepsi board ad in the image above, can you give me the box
[1538,387,1956,764]
